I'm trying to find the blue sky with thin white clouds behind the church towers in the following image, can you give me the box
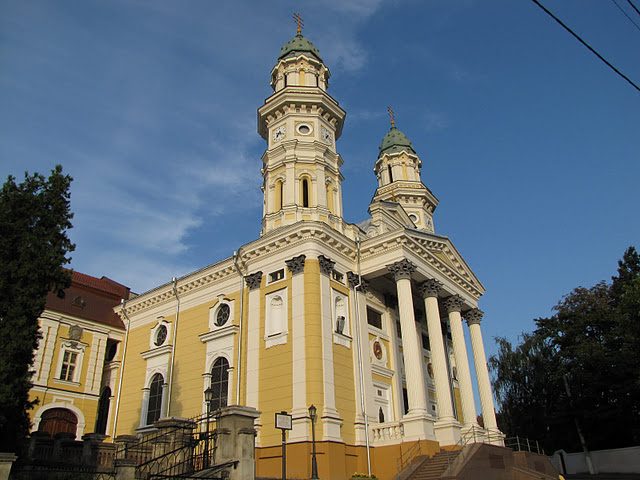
[0,0,640,360]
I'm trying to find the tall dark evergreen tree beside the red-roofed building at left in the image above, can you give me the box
[0,165,75,452]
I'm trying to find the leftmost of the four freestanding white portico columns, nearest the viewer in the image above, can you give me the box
[387,259,433,439]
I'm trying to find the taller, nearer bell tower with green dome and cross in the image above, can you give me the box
[258,15,346,235]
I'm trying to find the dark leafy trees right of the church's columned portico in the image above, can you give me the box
[489,247,640,451]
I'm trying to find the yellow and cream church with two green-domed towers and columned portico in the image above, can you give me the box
[107,25,502,479]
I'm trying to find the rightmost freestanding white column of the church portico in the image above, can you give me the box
[464,308,498,433]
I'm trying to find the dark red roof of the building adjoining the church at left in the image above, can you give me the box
[46,272,130,329]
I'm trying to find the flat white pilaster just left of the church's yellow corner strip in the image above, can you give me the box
[285,255,309,442]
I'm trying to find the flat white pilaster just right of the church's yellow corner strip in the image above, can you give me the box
[318,255,342,442]
